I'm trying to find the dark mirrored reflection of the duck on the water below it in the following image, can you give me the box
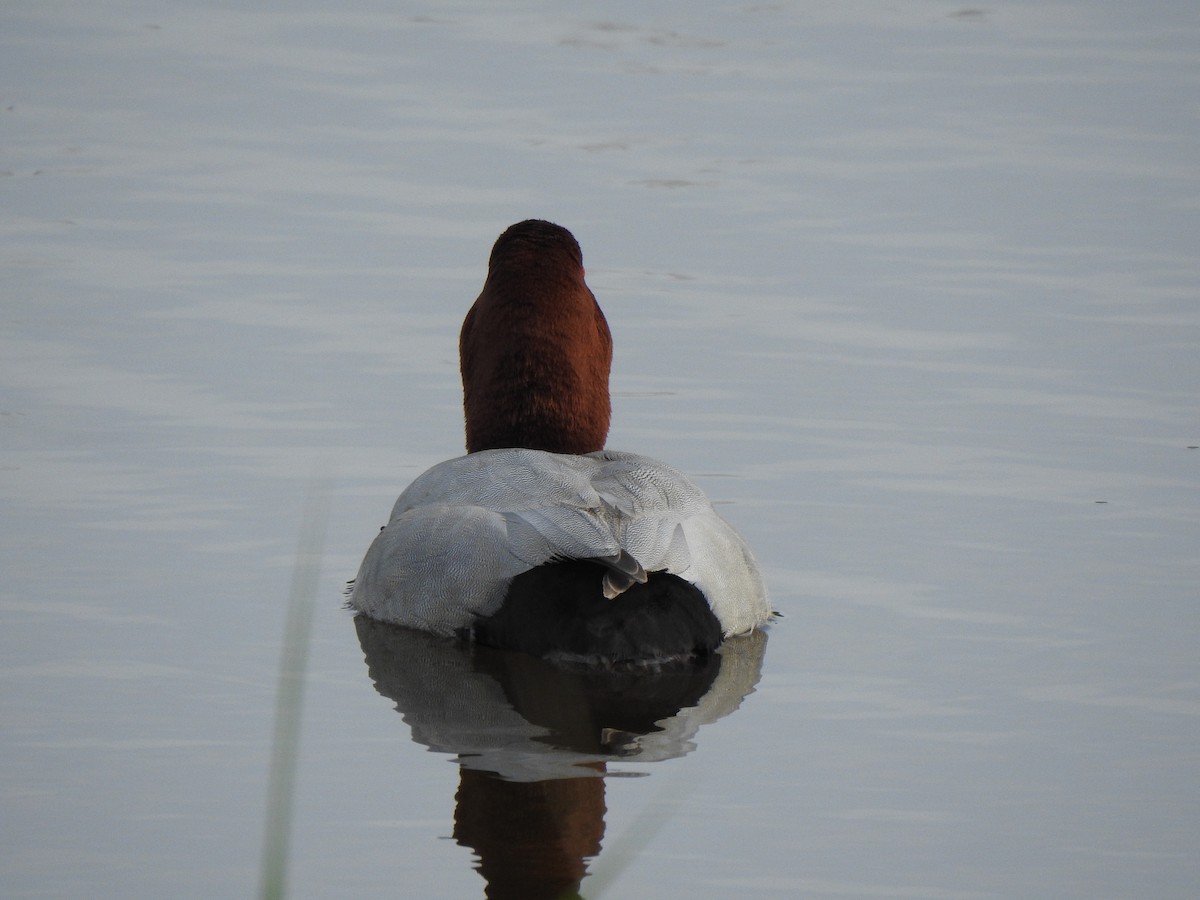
[354,616,767,900]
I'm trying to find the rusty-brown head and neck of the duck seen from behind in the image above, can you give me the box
[458,218,612,454]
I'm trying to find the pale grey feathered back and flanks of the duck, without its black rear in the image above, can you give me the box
[349,450,770,657]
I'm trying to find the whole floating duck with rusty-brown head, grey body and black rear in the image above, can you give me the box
[347,218,773,667]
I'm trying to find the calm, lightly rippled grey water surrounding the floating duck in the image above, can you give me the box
[0,0,1200,900]
